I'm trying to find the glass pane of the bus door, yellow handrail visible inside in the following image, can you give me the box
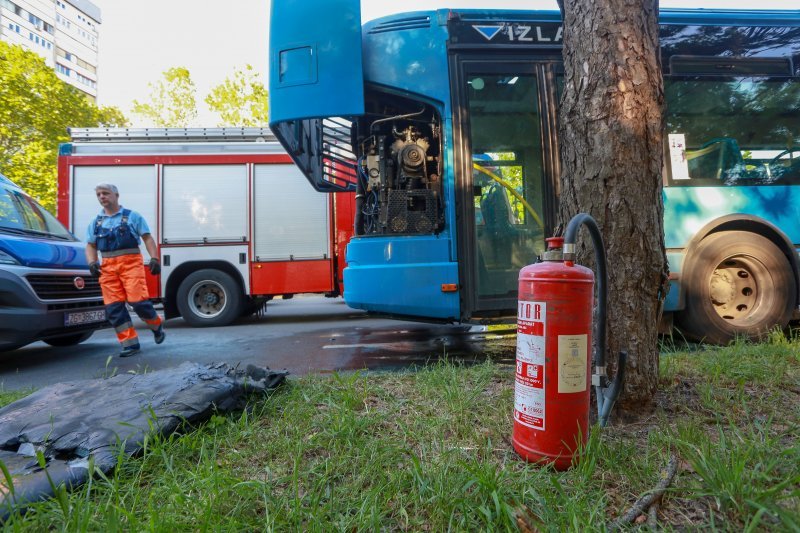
[466,73,544,297]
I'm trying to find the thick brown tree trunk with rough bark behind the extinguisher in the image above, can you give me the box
[559,0,667,409]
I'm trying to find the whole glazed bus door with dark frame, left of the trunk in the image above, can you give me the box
[453,57,558,321]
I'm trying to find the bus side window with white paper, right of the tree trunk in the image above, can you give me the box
[664,77,800,186]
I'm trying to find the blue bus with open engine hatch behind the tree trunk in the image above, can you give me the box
[270,4,800,343]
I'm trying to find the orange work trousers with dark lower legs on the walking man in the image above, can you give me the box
[100,254,162,347]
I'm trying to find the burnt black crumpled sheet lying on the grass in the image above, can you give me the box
[0,363,287,522]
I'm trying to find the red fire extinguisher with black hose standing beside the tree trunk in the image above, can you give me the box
[512,213,625,470]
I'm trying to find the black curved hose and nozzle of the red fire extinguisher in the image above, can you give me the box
[563,213,628,427]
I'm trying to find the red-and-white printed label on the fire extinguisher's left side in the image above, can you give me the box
[514,301,547,430]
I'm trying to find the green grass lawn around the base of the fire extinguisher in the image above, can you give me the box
[0,336,800,531]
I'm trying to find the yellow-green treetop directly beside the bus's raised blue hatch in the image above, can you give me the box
[206,65,269,127]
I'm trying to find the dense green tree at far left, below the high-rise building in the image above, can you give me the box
[0,42,127,213]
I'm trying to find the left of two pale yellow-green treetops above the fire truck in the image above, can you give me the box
[132,67,197,128]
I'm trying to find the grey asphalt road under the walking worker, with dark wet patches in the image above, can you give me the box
[0,296,515,390]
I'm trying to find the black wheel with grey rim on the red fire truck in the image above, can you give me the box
[178,269,242,327]
